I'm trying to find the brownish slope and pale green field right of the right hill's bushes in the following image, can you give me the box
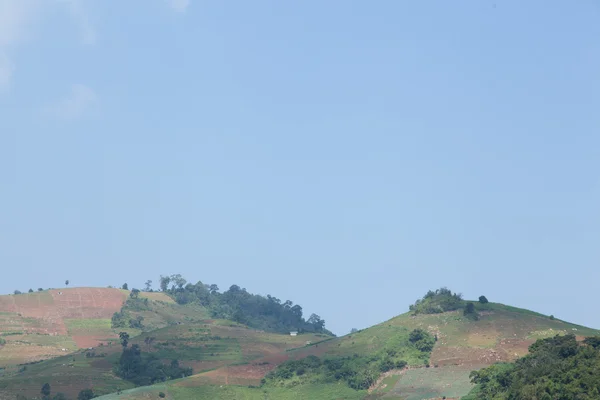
[370,303,600,400]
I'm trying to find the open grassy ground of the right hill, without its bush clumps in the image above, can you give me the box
[96,303,600,400]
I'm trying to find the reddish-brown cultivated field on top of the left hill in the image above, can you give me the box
[0,288,126,367]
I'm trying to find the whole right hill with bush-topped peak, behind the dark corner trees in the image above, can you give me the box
[90,291,600,400]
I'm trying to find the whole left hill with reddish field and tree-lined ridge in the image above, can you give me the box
[0,282,330,398]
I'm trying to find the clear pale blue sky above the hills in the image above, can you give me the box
[0,0,600,334]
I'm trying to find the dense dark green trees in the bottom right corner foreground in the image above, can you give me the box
[468,335,600,400]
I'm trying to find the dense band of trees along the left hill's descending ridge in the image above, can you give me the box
[154,274,333,336]
